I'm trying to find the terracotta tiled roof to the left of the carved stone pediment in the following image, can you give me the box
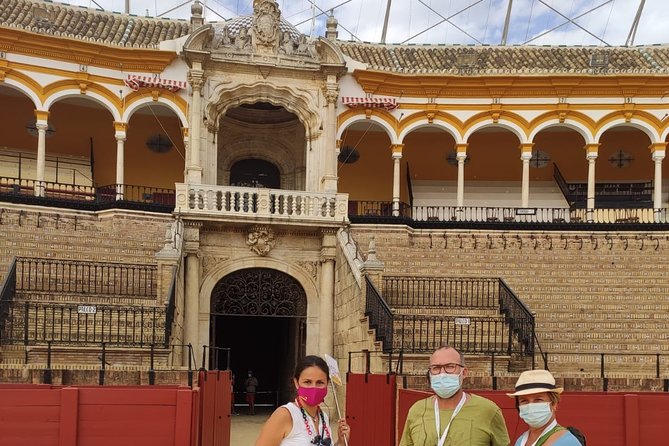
[0,0,190,48]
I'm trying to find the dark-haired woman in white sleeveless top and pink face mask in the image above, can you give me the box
[256,356,350,446]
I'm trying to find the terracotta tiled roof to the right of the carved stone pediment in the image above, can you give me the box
[337,41,669,76]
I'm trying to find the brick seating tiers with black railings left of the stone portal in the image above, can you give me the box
[0,204,173,370]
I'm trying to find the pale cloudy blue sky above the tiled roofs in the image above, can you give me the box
[56,0,669,46]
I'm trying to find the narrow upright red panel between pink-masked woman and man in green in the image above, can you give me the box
[346,373,396,446]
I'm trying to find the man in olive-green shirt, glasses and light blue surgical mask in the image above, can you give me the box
[400,346,510,446]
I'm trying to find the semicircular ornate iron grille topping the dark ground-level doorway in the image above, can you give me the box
[211,268,307,317]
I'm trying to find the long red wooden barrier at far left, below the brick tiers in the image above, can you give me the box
[0,385,198,446]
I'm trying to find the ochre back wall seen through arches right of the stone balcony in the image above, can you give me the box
[339,128,669,202]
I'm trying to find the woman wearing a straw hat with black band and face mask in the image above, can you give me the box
[507,370,581,446]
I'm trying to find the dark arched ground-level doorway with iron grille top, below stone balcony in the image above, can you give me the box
[210,268,307,407]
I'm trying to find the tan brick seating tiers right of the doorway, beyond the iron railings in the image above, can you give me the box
[352,225,669,377]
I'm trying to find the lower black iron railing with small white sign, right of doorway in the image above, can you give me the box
[393,314,512,355]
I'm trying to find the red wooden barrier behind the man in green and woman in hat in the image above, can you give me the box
[397,390,669,446]
